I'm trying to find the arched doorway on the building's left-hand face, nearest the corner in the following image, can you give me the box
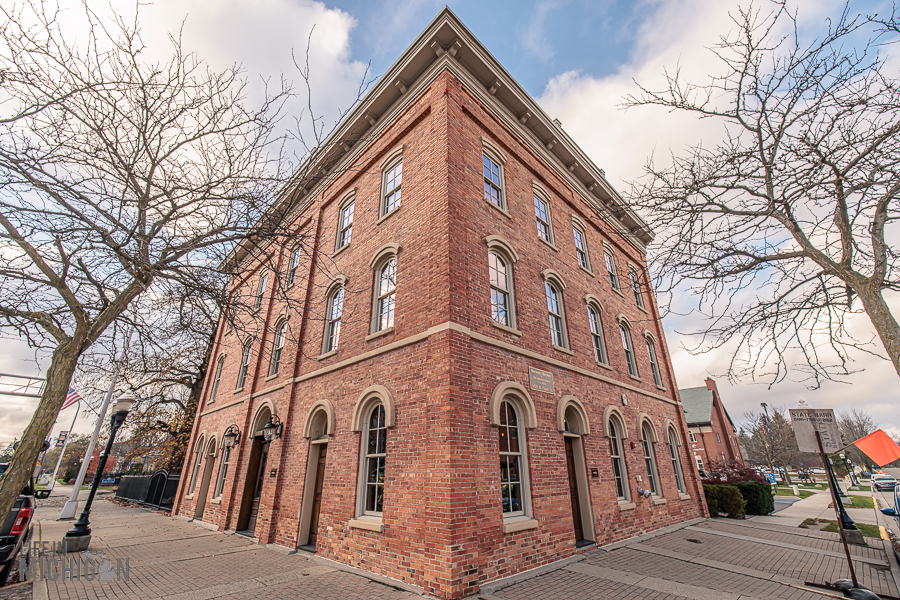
[297,400,334,552]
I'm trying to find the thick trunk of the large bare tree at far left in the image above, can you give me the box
[0,339,79,519]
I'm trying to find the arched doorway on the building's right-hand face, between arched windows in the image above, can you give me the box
[557,396,596,546]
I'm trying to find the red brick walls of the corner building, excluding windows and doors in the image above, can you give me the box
[174,72,705,598]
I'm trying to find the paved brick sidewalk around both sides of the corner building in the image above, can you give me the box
[19,500,900,600]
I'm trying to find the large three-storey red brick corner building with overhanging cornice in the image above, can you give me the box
[174,9,705,598]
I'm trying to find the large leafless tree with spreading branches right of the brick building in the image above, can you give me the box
[626,1,900,386]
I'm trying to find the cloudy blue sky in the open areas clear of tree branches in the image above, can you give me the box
[0,0,900,443]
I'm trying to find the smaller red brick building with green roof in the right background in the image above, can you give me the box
[678,378,744,470]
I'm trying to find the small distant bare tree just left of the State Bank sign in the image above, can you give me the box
[740,407,800,484]
